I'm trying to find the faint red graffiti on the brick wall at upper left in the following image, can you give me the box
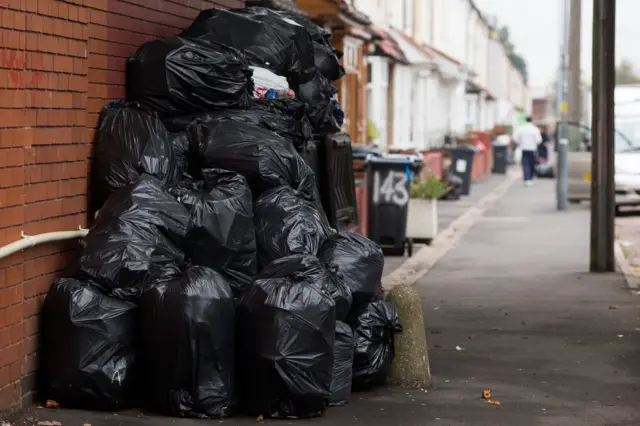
[0,34,44,89]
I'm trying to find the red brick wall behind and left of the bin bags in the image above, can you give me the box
[0,0,243,418]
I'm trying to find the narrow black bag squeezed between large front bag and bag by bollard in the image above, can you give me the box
[328,321,355,407]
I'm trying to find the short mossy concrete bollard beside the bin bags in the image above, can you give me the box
[386,284,431,388]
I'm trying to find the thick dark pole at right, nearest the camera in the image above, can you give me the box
[590,0,616,272]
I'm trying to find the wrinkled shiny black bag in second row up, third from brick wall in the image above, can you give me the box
[254,186,332,267]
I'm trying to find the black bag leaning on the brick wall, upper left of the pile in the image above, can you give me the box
[91,101,179,212]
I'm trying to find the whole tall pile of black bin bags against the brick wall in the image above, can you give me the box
[41,8,401,419]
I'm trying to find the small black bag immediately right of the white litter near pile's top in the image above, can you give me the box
[295,71,341,133]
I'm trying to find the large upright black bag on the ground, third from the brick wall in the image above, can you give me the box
[237,256,336,418]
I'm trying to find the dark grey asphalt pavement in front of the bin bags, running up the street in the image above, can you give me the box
[15,180,640,426]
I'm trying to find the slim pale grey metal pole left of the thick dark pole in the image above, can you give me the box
[556,0,568,210]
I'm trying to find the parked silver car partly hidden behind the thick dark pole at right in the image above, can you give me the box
[567,117,640,212]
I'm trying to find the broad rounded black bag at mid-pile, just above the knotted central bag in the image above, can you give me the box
[189,118,316,200]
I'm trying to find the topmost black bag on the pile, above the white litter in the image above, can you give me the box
[182,7,315,83]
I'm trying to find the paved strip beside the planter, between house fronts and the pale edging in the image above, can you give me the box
[383,175,506,276]
